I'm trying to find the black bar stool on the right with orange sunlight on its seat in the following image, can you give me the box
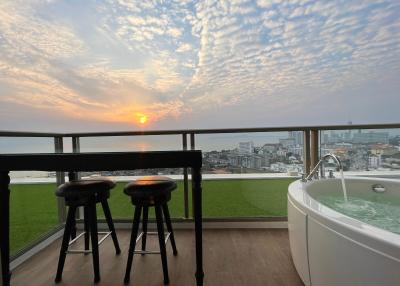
[124,176,178,284]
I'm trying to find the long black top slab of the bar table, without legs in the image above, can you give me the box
[0,150,202,171]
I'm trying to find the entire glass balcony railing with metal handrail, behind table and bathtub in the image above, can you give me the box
[0,124,400,260]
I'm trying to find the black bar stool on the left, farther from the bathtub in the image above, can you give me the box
[55,174,121,283]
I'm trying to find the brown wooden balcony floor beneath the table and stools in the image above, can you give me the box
[11,229,303,286]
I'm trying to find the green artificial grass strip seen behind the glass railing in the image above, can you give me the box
[10,179,293,254]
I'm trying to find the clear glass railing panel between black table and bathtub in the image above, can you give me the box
[196,131,303,218]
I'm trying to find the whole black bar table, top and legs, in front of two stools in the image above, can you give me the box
[0,150,204,286]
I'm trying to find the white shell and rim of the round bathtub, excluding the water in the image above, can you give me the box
[288,177,400,286]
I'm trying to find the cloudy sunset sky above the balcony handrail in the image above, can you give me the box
[0,0,400,132]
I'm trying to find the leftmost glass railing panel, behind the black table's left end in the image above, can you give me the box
[0,137,59,255]
